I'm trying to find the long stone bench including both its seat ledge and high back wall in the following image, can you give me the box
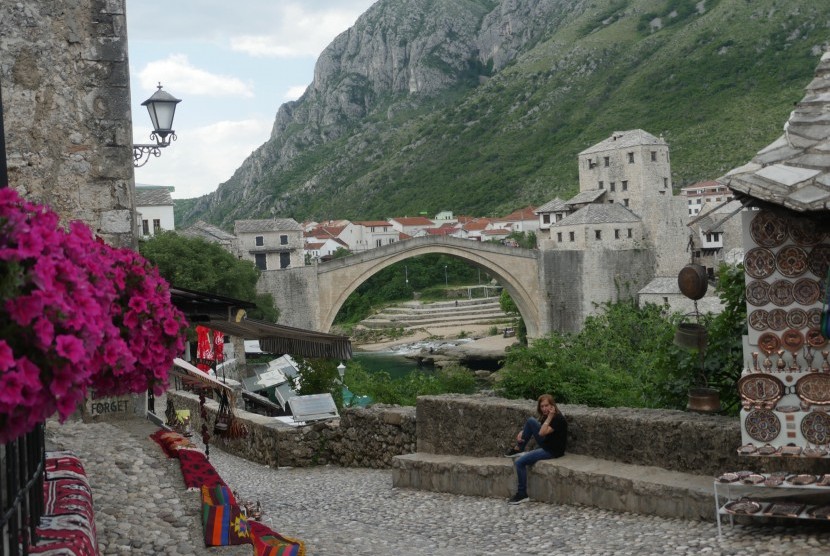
[392,395,825,521]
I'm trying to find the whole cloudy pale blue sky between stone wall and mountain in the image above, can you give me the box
[126,0,376,199]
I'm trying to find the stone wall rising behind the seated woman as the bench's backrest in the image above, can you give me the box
[416,395,827,476]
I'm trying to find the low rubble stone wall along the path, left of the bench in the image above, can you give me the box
[169,391,415,468]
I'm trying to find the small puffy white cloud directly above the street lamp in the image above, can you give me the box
[138,54,254,98]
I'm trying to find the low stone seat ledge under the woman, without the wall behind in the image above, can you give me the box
[392,452,715,521]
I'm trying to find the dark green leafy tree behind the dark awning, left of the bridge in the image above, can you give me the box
[139,232,279,322]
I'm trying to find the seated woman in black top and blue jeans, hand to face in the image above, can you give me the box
[505,394,568,504]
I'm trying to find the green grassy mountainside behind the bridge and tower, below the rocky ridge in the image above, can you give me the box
[177,0,830,228]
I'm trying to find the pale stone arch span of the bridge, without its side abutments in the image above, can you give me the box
[317,236,548,338]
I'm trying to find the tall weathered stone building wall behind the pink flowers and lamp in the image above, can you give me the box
[0,0,136,247]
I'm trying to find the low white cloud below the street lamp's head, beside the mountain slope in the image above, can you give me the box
[134,120,272,199]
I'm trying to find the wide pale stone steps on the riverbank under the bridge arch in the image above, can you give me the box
[360,297,514,330]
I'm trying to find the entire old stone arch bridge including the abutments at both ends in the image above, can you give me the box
[257,236,654,338]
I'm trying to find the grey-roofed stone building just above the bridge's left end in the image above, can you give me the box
[233,218,305,270]
